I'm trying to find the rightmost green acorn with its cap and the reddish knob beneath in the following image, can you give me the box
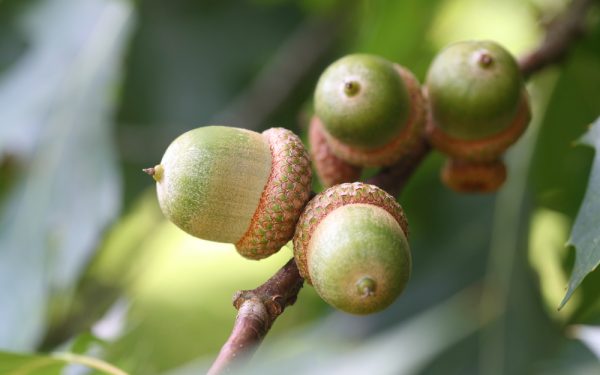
[425,41,531,192]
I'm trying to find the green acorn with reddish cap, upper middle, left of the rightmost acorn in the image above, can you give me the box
[315,54,426,167]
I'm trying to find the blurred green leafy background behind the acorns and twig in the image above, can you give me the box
[0,0,600,375]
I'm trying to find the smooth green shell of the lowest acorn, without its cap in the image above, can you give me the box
[308,204,411,314]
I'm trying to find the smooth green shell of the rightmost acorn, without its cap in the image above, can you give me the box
[425,41,524,140]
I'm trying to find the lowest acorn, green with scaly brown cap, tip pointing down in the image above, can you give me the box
[294,182,411,315]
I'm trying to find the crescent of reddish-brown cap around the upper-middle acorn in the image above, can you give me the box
[324,64,427,167]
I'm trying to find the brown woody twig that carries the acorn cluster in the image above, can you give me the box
[209,0,592,375]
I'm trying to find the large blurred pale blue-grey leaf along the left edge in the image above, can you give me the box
[0,0,132,350]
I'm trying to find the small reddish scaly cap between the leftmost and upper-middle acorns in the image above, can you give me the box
[308,116,362,187]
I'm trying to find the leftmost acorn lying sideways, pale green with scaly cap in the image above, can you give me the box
[145,126,312,259]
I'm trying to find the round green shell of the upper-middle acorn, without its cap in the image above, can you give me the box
[315,54,410,149]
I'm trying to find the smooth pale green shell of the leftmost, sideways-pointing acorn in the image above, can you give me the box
[155,126,272,243]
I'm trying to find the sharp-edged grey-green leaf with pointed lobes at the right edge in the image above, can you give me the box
[560,118,600,307]
